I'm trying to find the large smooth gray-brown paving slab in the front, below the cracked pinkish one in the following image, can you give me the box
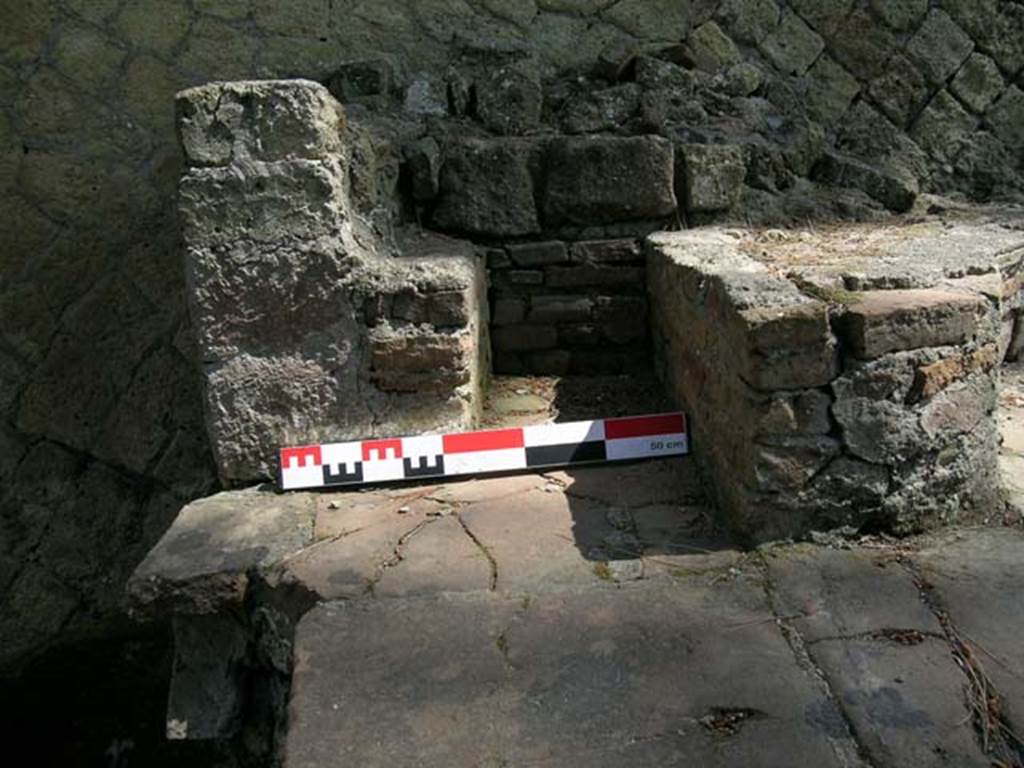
[285,579,859,768]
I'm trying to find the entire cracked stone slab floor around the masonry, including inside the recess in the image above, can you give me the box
[272,376,1024,768]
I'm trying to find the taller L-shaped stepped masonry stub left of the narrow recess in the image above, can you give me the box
[177,80,487,483]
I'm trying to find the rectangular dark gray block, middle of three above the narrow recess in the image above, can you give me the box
[544,136,676,224]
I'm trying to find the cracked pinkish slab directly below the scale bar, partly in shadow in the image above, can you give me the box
[281,459,741,600]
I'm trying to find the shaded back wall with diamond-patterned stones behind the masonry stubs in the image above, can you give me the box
[0,0,1024,668]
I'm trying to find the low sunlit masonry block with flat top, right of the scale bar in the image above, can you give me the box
[648,227,1024,542]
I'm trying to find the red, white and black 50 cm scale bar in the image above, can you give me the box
[280,413,689,490]
